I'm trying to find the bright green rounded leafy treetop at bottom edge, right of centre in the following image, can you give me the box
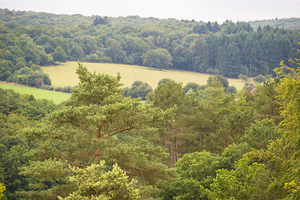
[205,159,276,200]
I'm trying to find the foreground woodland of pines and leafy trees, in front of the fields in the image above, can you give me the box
[0,55,300,200]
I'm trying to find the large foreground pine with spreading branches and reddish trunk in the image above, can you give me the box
[18,63,170,198]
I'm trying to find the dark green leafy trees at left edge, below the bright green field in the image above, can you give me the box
[0,88,58,200]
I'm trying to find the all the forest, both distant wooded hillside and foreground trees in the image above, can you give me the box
[0,9,300,200]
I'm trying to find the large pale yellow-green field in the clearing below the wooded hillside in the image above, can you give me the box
[41,61,244,90]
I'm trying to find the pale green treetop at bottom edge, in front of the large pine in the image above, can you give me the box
[58,161,139,200]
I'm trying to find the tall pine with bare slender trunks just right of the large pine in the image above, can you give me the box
[149,80,198,166]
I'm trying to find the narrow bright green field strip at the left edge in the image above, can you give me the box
[0,83,71,104]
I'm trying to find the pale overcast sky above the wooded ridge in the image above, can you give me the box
[0,0,300,23]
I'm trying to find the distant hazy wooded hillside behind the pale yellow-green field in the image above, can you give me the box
[0,9,300,87]
